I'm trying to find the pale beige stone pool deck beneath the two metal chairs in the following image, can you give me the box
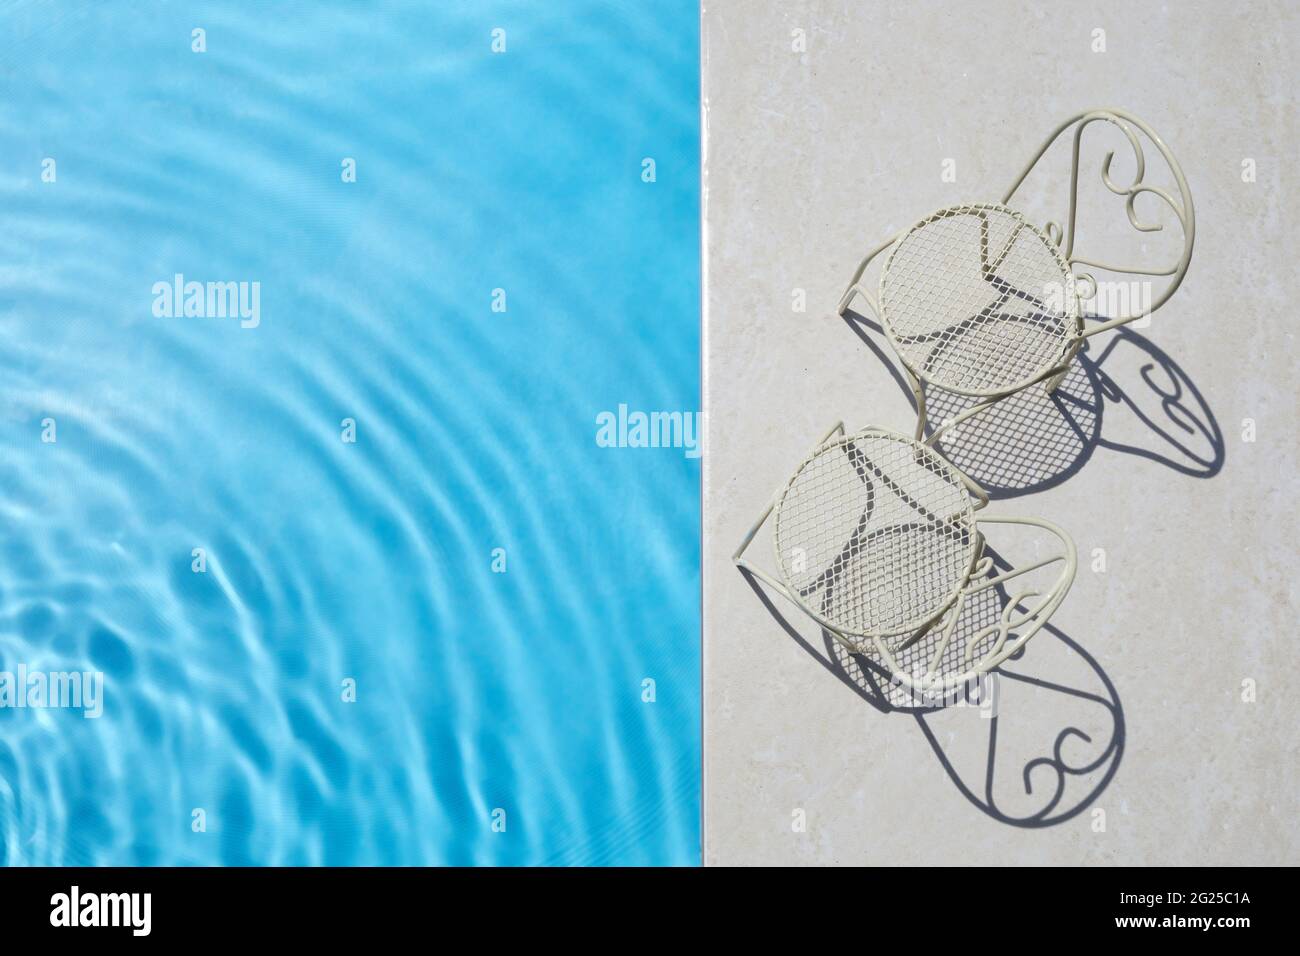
[702,0,1300,865]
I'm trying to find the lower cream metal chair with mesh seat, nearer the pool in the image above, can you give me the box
[732,423,1076,692]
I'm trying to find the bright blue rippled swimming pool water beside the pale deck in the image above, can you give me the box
[0,0,699,865]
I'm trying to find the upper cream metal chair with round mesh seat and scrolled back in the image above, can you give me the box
[837,109,1196,468]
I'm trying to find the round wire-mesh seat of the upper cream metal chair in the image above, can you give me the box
[880,206,1078,395]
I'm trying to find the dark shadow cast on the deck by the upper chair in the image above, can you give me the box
[844,310,1226,498]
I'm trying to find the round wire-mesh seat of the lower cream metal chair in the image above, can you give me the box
[775,433,978,637]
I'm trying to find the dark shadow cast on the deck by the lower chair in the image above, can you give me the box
[741,549,1125,829]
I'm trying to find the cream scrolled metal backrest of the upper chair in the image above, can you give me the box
[1002,108,1196,336]
